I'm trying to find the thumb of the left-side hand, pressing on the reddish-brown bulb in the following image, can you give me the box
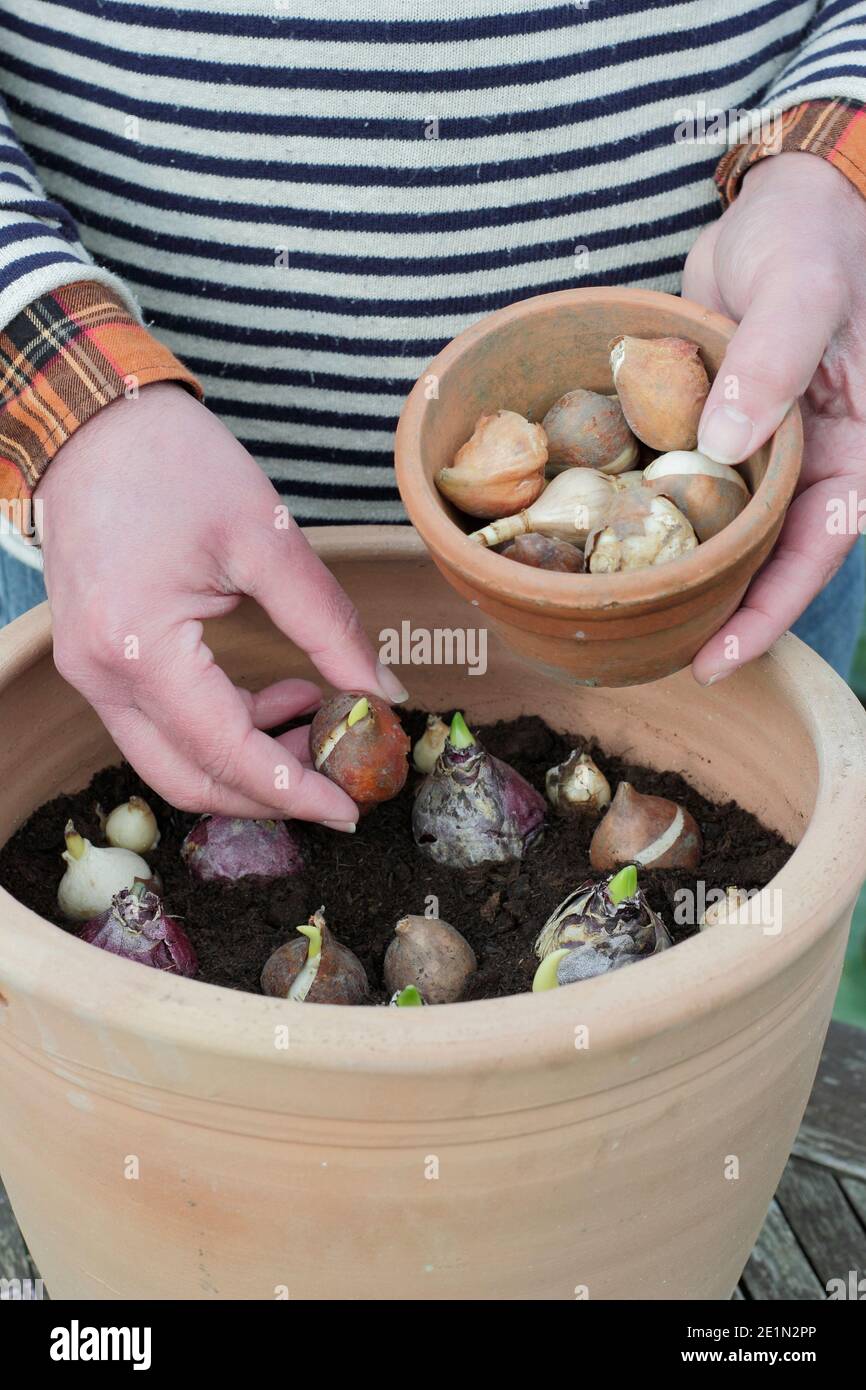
[232,525,409,705]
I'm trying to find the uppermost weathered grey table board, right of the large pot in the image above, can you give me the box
[794,1023,866,1179]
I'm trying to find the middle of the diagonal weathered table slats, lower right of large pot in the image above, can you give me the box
[776,1158,866,1287]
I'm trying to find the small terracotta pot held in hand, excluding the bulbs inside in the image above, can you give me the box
[396,289,802,685]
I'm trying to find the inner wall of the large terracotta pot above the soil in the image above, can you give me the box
[0,527,820,853]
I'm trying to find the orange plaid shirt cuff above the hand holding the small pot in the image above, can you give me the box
[716,101,866,207]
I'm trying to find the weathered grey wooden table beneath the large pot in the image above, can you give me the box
[0,1023,866,1301]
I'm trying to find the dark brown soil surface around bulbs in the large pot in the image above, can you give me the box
[0,712,794,999]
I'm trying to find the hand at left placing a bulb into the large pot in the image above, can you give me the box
[36,382,406,830]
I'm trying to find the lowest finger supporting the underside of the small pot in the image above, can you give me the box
[692,478,858,685]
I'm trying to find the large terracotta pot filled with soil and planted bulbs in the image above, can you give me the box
[0,528,866,1300]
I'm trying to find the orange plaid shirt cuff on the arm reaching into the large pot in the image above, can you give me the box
[0,281,203,524]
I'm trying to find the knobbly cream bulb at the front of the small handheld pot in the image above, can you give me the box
[585,488,698,574]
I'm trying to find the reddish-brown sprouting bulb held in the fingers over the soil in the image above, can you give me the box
[310,691,411,809]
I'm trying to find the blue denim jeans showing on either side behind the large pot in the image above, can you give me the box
[0,541,866,680]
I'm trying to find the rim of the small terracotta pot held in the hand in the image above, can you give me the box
[395,286,802,613]
